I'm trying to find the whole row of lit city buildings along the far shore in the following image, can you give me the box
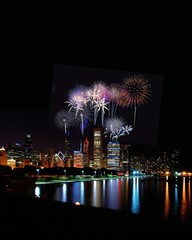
[0,128,179,174]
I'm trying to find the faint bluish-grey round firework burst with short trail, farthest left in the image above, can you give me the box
[54,109,74,134]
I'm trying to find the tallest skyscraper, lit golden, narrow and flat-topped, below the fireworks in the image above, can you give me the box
[93,128,103,169]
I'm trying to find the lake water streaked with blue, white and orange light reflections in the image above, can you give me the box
[35,177,192,223]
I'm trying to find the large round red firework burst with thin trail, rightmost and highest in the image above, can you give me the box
[122,75,151,127]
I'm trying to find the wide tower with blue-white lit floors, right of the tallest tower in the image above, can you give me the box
[107,141,120,170]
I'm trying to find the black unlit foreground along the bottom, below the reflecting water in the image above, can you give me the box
[0,194,192,239]
